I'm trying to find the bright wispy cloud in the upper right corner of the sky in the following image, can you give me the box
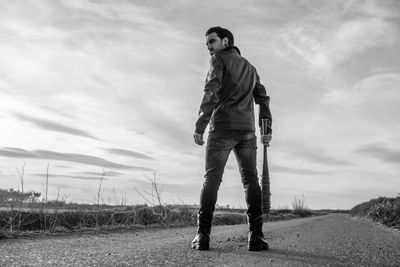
[276,1,399,70]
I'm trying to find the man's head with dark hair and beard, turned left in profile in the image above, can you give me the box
[206,26,234,55]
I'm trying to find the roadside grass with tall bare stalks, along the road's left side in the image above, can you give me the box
[0,163,344,239]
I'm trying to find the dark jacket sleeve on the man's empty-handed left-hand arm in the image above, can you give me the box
[196,55,224,134]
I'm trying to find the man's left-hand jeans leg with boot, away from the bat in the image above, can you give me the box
[192,133,232,250]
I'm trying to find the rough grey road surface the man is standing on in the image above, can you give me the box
[0,214,400,266]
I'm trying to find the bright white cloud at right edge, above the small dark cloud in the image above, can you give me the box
[322,72,400,130]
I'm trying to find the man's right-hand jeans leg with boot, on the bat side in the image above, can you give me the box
[234,133,268,251]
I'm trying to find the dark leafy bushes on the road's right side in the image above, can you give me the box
[350,194,400,229]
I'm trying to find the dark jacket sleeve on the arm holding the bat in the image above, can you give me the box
[253,71,272,133]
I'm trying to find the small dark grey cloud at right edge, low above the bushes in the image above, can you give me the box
[354,143,400,165]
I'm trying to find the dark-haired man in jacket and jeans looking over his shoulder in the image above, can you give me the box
[192,27,272,251]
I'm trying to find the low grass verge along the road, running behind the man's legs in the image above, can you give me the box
[0,201,334,241]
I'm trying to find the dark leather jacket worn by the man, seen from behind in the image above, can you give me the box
[196,46,272,134]
